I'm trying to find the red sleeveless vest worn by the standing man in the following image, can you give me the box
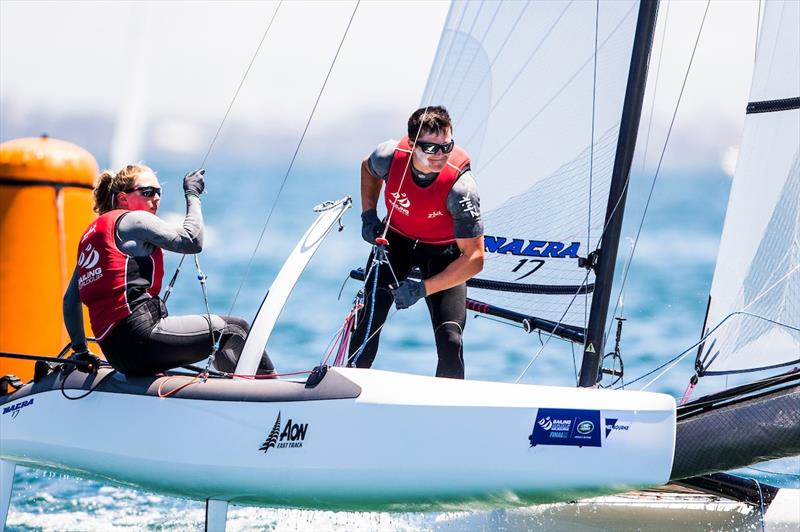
[383,137,469,244]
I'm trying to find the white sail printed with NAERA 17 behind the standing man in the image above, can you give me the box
[422,1,639,328]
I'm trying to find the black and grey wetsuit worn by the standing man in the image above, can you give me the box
[348,141,483,379]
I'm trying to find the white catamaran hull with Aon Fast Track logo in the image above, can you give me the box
[0,368,675,509]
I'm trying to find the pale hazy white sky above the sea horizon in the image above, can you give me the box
[0,0,759,171]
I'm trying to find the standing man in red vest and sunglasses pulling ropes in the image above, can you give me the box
[348,106,484,379]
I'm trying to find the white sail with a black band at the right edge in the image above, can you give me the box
[704,0,800,374]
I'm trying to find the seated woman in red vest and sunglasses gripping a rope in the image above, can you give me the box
[64,164,274,375]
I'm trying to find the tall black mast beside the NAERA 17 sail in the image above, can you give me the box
[578,0,658,387]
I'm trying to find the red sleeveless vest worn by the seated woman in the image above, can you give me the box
[78,209,164,340]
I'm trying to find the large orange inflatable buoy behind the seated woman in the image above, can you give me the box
[0,136,98,381]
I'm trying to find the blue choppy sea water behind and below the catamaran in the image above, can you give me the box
[3,161,800,531]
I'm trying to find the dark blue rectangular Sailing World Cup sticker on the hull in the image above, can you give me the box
[528,408,602,447]
